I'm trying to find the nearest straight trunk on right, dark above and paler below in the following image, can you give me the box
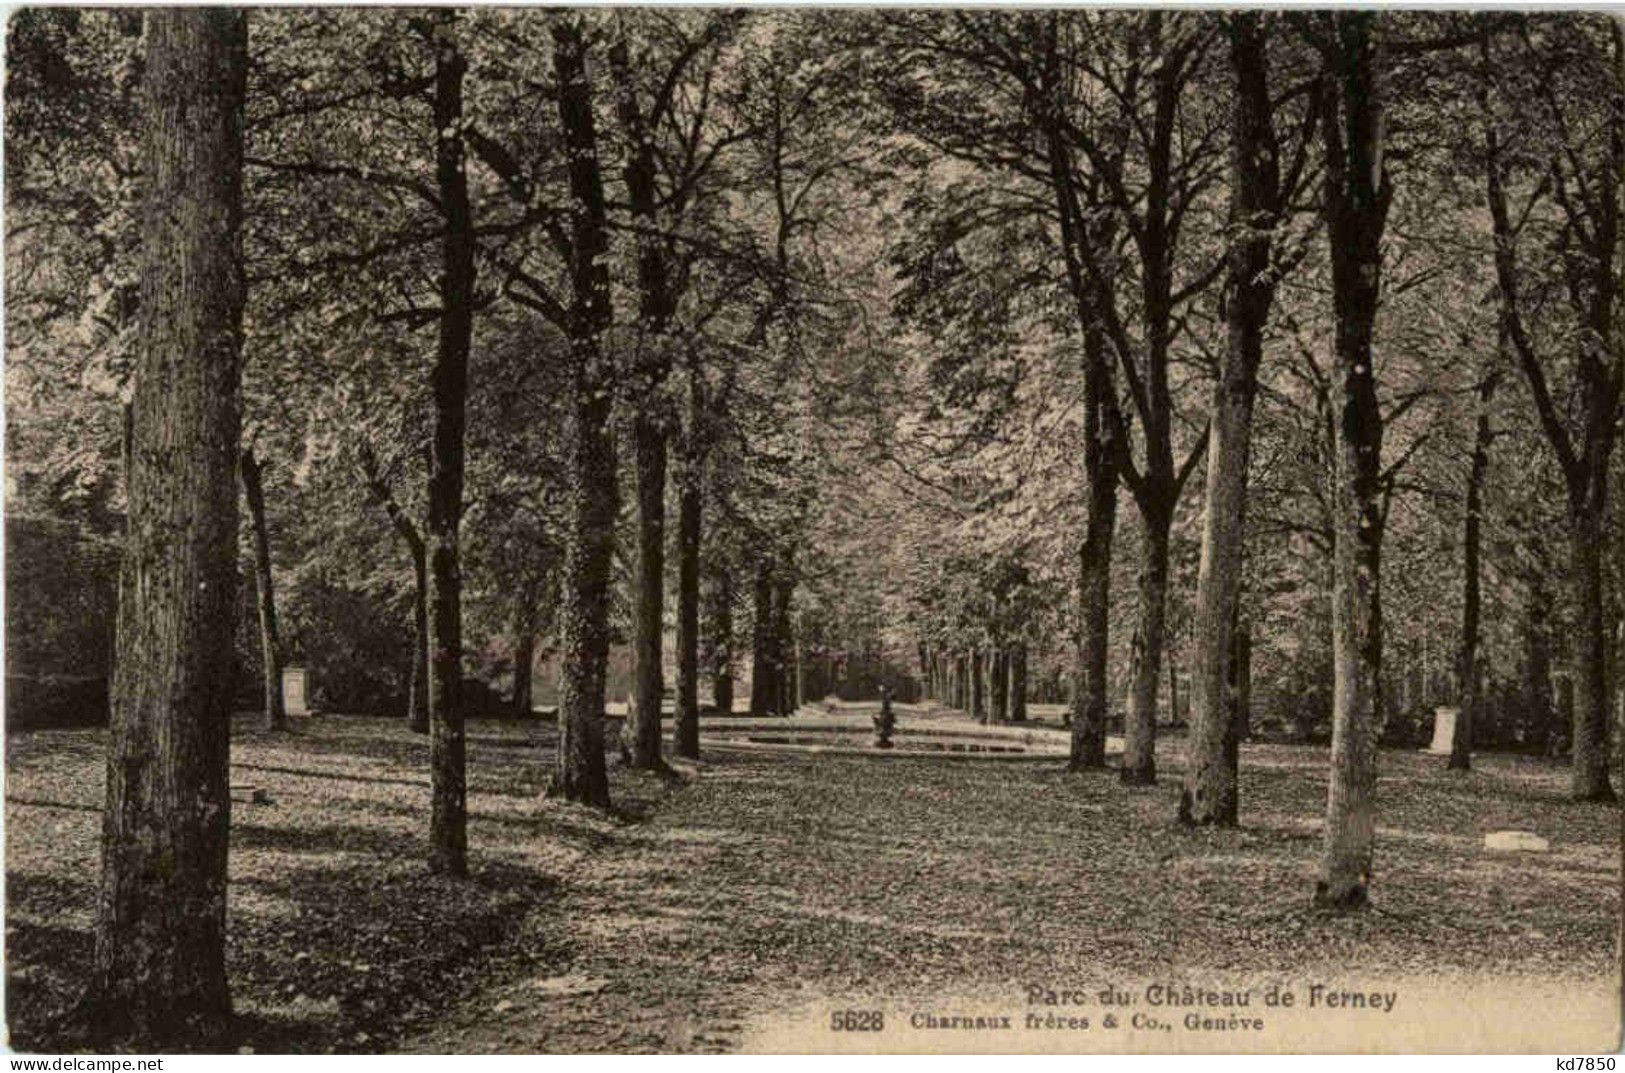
[1315,11,1393,910]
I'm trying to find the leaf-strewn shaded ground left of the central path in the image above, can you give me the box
[7,719,665,1052]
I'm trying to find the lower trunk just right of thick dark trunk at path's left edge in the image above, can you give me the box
[622,415,666,771]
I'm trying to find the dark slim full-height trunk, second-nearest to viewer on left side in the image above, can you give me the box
[426,10,475,876]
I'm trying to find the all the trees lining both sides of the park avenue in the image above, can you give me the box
[7,8,1625,1040]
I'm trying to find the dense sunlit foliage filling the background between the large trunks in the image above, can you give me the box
[7,10,1622,822]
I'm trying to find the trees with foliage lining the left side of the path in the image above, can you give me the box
[8,8,863,1042]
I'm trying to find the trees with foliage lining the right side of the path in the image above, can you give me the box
[845,11,1625,907]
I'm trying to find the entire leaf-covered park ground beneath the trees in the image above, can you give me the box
[7,717,1620,1052]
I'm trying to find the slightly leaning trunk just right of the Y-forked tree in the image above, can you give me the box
[1180,11,1281,826]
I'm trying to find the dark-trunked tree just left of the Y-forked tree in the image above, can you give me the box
[887,11,1126,769]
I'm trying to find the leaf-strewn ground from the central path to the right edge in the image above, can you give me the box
[405,746,1619,1052]
